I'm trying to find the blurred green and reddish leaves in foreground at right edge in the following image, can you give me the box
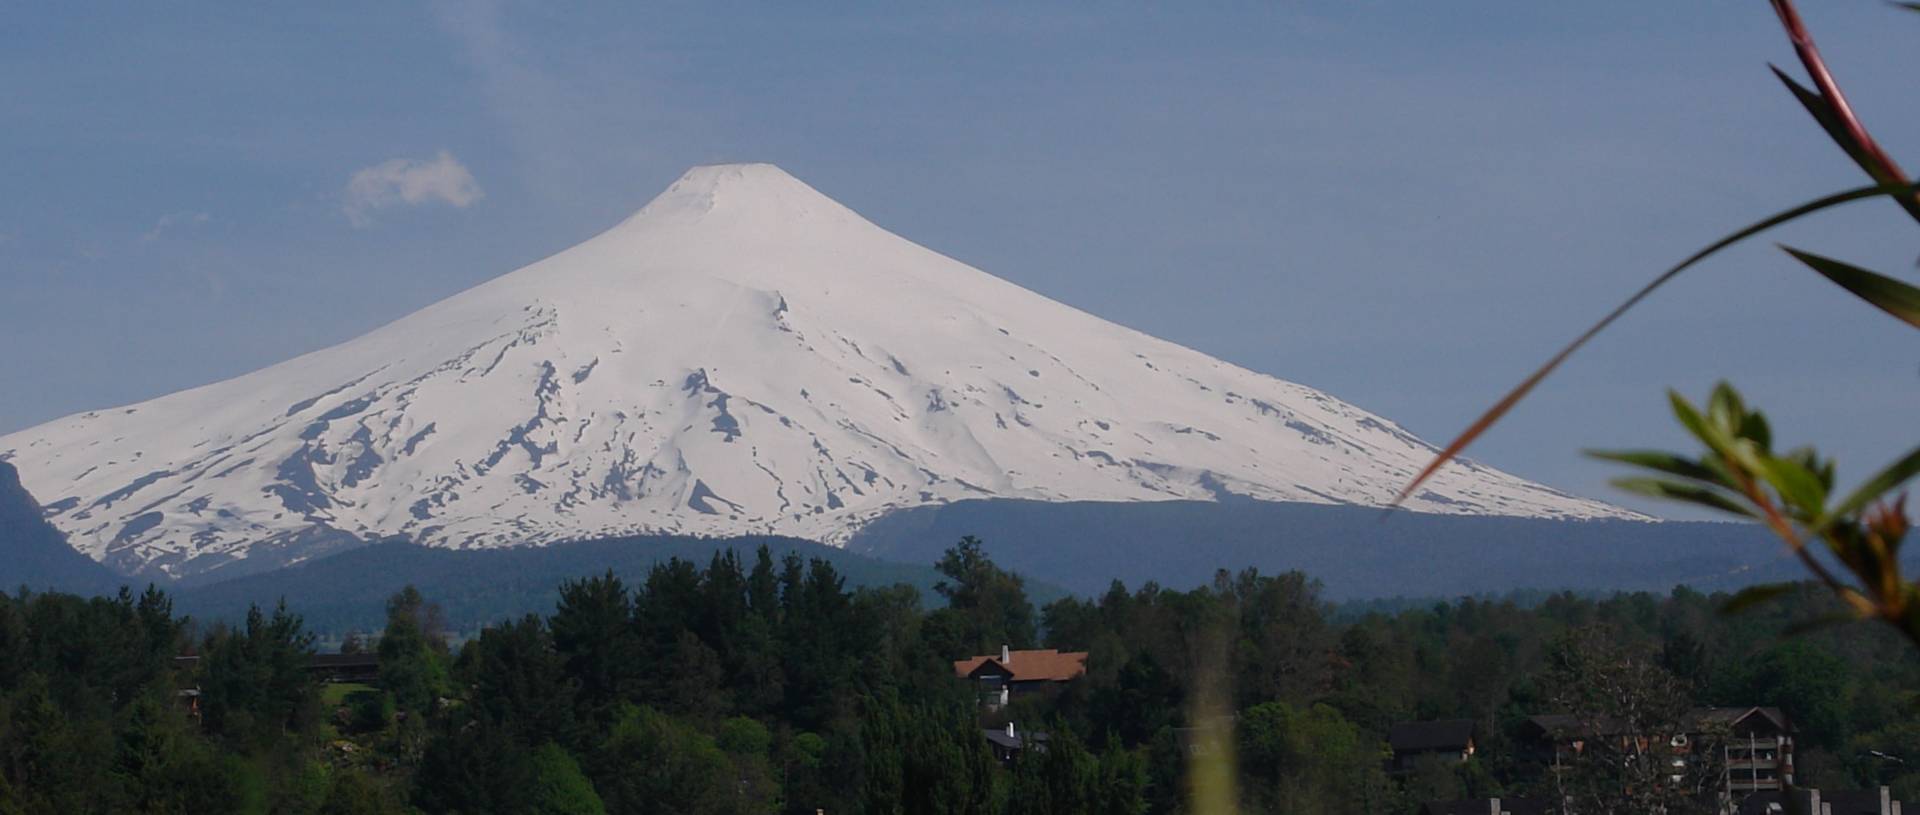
[1402,0,1920,644]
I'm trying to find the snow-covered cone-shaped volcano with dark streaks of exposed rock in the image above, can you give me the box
[0,163,1628,577]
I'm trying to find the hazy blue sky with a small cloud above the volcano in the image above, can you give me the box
[0,0,1920,511]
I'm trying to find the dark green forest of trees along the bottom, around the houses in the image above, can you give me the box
[0,540,1920,815]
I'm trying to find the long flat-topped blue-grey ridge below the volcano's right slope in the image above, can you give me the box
[849,500,1807,600]
